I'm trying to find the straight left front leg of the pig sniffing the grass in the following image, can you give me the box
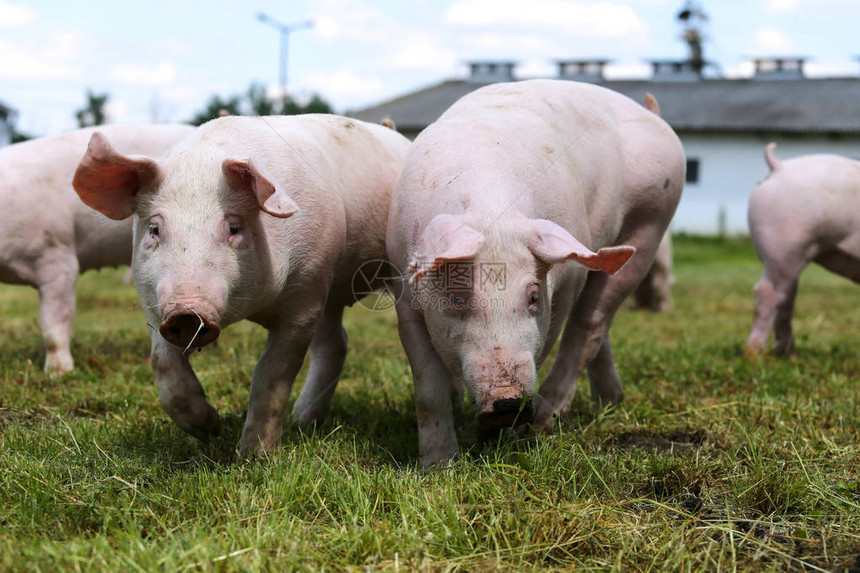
[397,289,462,468]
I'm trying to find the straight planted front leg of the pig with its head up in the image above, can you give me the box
[239,313,318,455]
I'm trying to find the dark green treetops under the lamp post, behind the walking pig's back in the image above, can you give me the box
[189,83,333,125]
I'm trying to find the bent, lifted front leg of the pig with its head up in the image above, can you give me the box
[151,332,221,442]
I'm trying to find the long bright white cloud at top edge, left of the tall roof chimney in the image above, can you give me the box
[445,0,646,38]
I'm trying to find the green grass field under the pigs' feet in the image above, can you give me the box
[0,237,860,572]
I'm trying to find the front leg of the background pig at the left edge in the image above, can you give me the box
[36,253,78,376]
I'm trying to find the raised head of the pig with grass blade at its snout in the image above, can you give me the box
[73,132,298,348]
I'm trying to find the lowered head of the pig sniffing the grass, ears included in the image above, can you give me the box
[408,214,635,427]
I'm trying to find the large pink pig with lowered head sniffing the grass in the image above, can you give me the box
[387,80,686,466]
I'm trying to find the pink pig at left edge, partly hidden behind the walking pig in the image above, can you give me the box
[0,125,194,376]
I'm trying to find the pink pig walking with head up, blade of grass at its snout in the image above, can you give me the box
[73,114,409,455]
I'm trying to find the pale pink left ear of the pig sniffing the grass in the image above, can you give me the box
[407,214,484,283]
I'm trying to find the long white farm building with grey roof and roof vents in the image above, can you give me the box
[349,58,860,233]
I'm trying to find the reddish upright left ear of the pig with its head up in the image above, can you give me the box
[72,131,159,221]
